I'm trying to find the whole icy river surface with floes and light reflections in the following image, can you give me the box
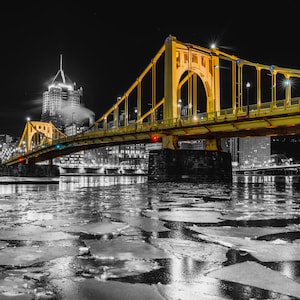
[0,175,300,300]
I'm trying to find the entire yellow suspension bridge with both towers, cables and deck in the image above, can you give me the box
[2,36,300,165]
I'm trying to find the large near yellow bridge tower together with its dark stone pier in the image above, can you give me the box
[149,36,232,181]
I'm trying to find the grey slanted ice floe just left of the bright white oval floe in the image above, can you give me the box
[111,213,170,232]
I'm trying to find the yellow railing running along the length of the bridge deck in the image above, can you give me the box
[3,97,300,165]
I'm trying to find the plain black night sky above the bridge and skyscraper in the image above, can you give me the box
[0,0,300,136]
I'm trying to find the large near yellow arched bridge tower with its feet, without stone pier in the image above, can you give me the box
[162,36,221,151]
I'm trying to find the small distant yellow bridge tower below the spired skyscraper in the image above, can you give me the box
[18,121,66,152]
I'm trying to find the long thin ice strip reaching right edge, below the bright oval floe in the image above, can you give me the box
[186,225,299,238]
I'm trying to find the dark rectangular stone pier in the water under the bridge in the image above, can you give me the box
[148,149,232,182]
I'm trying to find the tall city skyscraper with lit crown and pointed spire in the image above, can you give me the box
[41,55,83,130]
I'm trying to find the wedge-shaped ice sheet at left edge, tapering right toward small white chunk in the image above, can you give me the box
[0,246,78,267]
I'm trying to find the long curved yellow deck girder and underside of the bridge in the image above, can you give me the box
[5,117,300,165]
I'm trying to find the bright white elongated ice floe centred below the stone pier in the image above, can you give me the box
[158,208,223,223]
